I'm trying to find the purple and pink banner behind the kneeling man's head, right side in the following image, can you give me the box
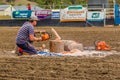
[35,10,52,19]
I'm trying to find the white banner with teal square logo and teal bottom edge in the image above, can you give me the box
[87,11,105,21]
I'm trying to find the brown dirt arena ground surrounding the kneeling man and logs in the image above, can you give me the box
[0,27,120,80]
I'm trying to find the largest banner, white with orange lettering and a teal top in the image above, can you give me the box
[60,5,86,22]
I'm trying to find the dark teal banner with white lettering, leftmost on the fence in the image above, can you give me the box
[12,10,32,19]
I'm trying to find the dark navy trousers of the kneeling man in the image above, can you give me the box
[16,42,37,55]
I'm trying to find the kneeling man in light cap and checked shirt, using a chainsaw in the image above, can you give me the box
[16,17,42,55]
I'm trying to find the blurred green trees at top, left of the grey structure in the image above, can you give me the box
[25,0,87,9]
